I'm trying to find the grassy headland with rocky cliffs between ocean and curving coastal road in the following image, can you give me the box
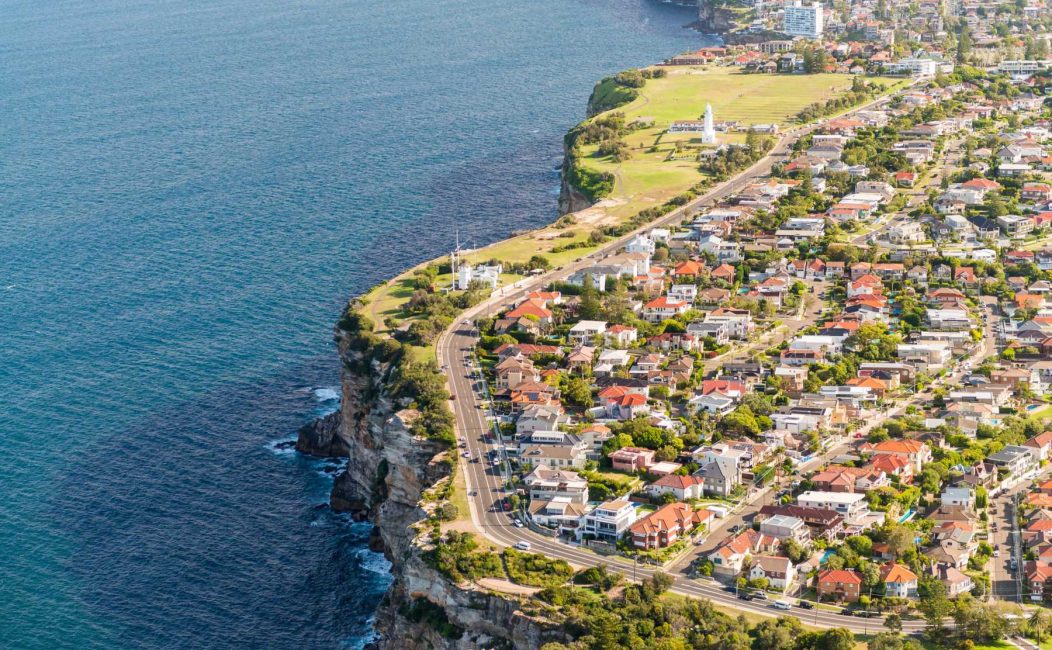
[298,66,903,649]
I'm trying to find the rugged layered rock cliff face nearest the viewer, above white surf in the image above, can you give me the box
[297,336,562,650]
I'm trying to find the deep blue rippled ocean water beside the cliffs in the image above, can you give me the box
[0,0,702,649]
